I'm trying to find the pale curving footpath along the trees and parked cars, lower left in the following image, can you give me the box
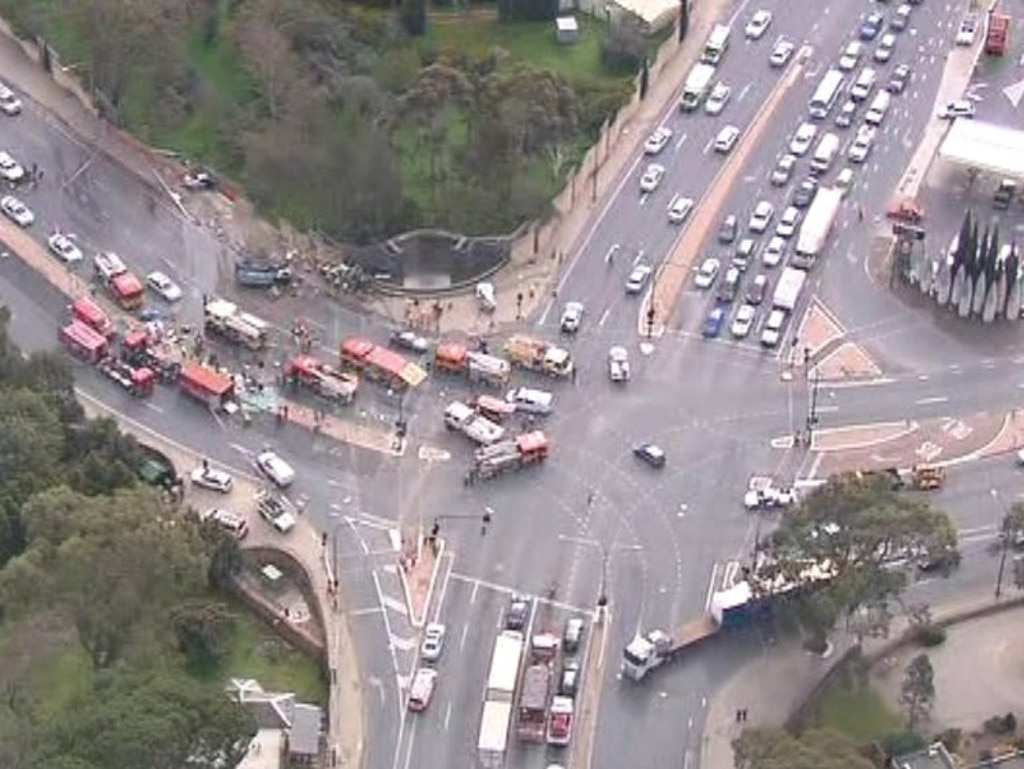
[78,392,365,769]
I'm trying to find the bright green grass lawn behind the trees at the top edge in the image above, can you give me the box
[421,12,608,80]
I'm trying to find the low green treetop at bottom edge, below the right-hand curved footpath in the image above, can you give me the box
[732,728,872,769]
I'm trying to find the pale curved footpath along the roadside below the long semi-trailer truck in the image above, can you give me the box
[699,589,1024,769]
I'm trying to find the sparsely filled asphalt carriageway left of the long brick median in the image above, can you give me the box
[541,0,807,336]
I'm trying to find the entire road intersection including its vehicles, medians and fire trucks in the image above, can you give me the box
[0,0,1024,769]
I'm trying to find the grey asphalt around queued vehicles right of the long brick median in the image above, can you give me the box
[683,3,949,364]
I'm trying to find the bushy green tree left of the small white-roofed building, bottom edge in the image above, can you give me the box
[27,668,256,769]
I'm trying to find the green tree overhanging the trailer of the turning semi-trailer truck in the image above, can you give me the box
[765,473,956,637]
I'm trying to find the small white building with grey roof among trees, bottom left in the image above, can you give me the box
[227,678,324,769]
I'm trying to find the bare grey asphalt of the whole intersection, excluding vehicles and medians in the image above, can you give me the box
[0,0,1024,769]
